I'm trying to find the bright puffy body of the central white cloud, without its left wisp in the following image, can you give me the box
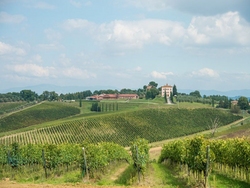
[99,19,185,48]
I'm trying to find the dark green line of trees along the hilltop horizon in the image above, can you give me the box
[0,81,250,112]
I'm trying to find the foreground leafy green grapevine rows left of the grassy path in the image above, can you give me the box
[0,142,132,181]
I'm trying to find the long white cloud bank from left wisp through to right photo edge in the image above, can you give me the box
[63,12,250,50]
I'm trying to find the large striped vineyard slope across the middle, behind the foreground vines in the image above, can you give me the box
[0,108,242,146]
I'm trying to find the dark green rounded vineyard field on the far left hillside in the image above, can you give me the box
[0,102,80,132]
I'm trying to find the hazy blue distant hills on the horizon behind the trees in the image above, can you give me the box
[0,84,250,99]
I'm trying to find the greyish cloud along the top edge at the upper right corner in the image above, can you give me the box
[127,0,250,21]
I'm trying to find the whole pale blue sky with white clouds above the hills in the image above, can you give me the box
[0,0,250,91]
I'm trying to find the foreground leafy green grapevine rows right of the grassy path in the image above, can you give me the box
[159,137,250,186]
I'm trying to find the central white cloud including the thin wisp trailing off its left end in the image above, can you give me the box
[63,19,185,49]
